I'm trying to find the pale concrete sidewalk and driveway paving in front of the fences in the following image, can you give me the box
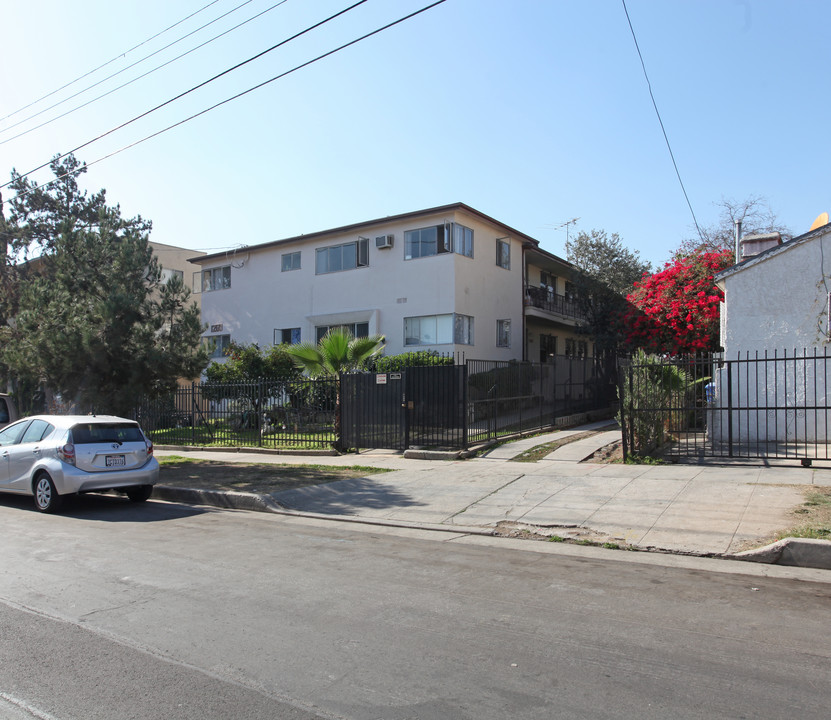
[155,424,831,555]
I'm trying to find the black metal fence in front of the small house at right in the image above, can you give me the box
[619,349,831,464]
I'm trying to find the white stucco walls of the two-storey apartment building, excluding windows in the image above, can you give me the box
[201,210,522,360]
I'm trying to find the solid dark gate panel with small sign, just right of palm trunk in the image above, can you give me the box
[340,372,409,450]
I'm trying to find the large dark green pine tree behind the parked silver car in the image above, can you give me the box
[0,155,208,414]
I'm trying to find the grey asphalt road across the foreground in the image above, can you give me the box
[0,496,831,720]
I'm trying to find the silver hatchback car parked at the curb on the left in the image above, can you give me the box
[0,415,159,513]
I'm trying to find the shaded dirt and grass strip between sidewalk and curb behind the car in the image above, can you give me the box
[159,457,386,493]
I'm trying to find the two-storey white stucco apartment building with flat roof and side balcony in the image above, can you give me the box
[191,203,591,361]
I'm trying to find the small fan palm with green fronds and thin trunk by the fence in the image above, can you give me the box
[287,328,385,450]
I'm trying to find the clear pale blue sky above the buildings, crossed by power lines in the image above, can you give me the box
[0,0,831,263]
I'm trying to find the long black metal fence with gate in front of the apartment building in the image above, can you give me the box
[136,356,614,450]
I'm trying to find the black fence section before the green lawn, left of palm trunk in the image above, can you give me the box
[136,379,337,449]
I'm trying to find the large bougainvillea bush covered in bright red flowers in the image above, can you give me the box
[623,251,733,355]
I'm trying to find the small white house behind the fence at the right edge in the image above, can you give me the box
[710,224,831,445]
